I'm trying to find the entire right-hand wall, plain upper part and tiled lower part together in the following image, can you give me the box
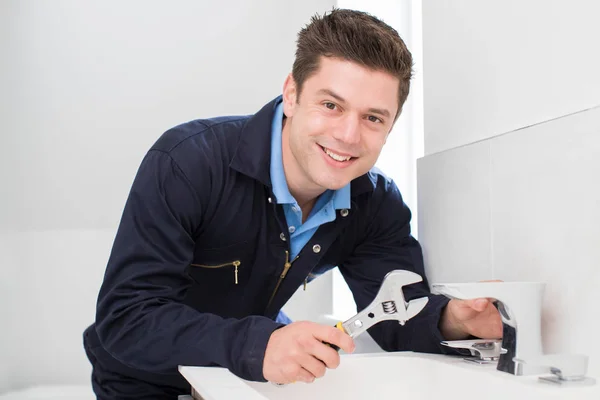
[418,0,600,378]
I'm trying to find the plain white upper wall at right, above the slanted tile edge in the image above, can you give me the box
[423,0,600,154]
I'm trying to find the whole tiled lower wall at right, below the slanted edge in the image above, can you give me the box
[418,107,600,377]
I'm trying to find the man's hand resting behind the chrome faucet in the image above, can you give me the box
[440,298,502,340]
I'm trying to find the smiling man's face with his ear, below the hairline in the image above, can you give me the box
[283,57,399,192]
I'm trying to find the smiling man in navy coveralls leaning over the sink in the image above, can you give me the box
[84,10,501,399]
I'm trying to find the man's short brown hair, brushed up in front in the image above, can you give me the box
[292,8,413,119]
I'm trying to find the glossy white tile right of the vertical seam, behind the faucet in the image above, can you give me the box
[490,107,600,365]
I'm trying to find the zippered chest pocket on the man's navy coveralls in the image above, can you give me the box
[188,241,254,290]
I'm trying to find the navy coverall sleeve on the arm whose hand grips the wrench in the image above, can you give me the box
[96,150,282,381]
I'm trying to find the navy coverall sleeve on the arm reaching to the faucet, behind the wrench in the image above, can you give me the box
[339,180,458,354]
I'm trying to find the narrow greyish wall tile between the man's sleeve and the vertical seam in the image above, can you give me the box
[417,142,492,282]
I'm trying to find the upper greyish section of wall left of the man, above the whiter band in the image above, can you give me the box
[0,0,333,230]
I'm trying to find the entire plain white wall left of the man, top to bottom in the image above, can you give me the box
[0,0,334,393]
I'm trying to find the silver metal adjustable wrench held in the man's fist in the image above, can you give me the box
[342,270,429,337]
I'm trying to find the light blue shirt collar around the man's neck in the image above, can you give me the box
[271,101,350,209]
